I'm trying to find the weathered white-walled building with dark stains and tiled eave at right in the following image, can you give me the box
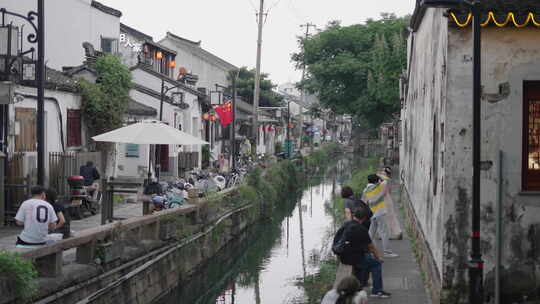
[400,0,540,303]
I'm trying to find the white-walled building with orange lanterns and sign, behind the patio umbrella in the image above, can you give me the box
[117,24,206,177]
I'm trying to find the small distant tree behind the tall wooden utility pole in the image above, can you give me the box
[229,67,283,107]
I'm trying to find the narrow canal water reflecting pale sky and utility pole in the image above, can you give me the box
[158,158,353,304]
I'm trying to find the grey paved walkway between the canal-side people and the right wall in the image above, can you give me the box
[337,185,430,304]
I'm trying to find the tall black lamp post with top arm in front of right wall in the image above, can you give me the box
[420,0,484,304]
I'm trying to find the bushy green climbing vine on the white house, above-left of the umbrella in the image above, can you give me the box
[79,56,132,136]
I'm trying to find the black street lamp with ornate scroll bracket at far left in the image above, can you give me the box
[0,0,45,185]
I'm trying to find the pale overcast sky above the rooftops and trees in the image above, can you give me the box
[100,0,416,84]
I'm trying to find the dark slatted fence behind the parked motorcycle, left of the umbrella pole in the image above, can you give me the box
[49,152,103,196]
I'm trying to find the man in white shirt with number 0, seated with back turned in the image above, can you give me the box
[15,186,58,246]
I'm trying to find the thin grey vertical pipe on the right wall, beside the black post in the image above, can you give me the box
[495,151,504,304]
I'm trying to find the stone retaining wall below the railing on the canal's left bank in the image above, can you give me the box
[33,204,259,304]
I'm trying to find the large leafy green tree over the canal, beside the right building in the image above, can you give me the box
[292,14,409,127]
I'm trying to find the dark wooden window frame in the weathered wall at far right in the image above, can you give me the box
[521,81,540,191]
